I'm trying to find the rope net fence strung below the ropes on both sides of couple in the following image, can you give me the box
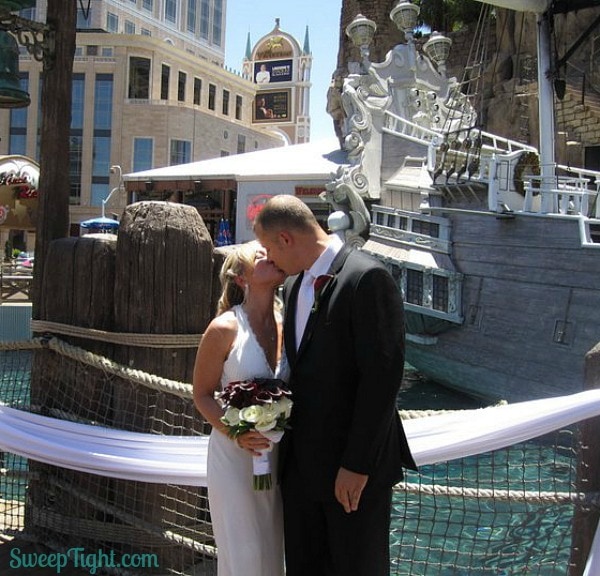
[0,338,594,576]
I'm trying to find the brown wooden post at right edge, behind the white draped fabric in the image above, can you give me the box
[569,343,600,576]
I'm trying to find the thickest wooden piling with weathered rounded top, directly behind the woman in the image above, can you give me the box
[114,202,213,570]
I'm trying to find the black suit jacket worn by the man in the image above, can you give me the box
[280,246,416,500]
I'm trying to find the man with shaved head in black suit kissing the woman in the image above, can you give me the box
[254,195,416,576]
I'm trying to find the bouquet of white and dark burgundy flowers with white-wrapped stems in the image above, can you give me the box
[218,378,292,490]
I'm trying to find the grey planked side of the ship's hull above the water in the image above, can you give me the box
[394,213,600,402]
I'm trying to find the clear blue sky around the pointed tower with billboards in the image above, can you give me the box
[225,0,342,142]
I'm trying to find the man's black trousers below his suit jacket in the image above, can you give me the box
[281,454,392,576]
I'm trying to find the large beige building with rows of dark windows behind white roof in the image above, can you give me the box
[0,0,310,250]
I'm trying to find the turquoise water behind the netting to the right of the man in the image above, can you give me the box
[390,372,575,576]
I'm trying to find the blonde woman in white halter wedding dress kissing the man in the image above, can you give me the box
[193,242,289,576]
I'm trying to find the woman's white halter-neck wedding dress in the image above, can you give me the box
[207,306,289,576]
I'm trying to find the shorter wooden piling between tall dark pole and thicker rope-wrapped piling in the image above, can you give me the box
[25,234,117,545]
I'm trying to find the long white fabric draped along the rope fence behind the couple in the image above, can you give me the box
[0,390,600,576]
